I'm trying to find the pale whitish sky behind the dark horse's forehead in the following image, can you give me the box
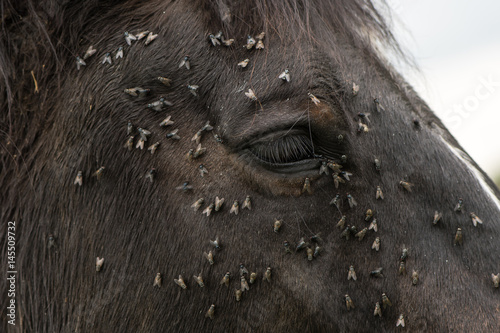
[380,0,500,184]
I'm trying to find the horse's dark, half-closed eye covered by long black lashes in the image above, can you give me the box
[249,135,313,164]
